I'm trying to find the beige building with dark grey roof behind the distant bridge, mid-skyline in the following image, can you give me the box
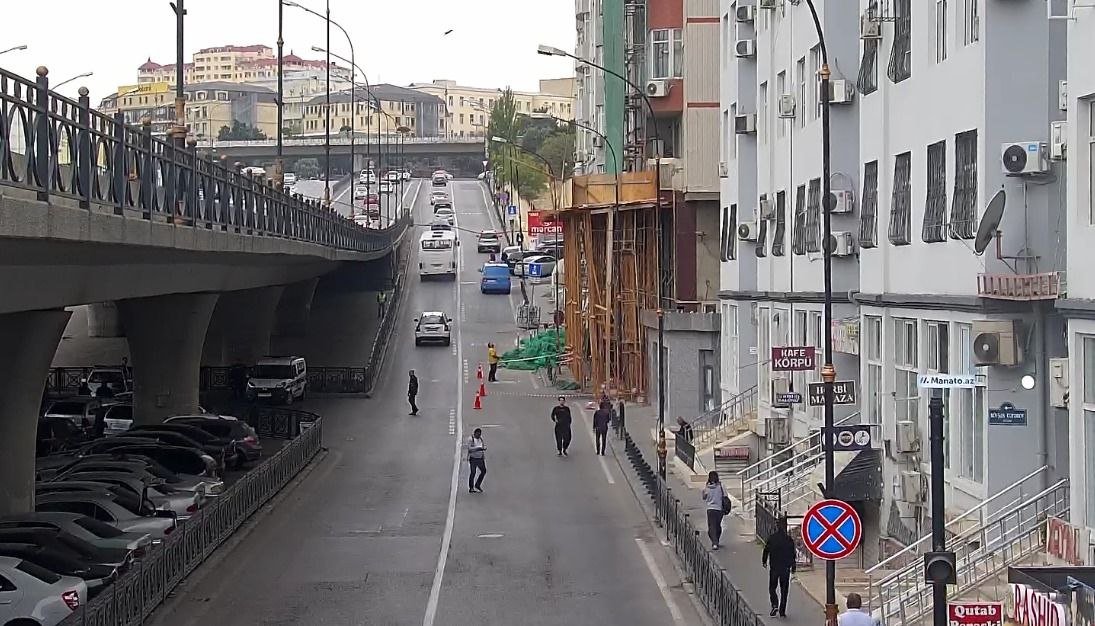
[301,84,445,137]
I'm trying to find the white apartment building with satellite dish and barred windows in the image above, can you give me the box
[721,0,1068,563]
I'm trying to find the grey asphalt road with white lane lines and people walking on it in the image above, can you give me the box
[153,181,702,626]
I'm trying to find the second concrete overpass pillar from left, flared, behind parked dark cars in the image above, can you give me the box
[118,293,218,424]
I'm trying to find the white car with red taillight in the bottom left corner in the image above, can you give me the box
[0,556,88,626]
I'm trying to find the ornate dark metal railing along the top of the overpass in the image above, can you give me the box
[0,68,408,253]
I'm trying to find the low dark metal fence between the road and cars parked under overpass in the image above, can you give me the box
[60,407,323,626]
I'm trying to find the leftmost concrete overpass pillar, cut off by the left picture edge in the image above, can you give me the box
[0,310,72,515]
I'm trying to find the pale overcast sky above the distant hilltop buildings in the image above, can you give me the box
[0,0,575,102]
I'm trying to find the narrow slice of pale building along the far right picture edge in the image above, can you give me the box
[1054,2,1095,565]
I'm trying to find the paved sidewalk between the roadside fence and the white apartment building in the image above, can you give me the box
[611,404,825,626]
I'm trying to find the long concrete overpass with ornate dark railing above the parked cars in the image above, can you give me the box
[0,63,411,514]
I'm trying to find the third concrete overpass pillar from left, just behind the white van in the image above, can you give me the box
[201,286,285,366]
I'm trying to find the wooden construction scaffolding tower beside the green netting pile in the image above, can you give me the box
[560,171,658,399]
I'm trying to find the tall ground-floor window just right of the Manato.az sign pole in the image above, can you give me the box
[950,324,984,483]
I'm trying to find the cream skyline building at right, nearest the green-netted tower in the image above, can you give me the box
[408,78,574,137]
